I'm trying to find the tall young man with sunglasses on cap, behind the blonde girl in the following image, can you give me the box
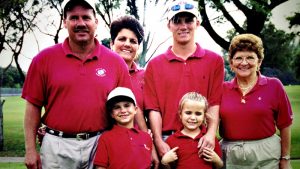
[144,0,224,160]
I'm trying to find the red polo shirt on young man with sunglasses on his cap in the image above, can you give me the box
[144,44,224,131]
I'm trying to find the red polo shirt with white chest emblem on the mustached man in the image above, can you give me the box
[22,39,131,133]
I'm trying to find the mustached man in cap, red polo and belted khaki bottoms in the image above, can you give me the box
[22,0,131,169]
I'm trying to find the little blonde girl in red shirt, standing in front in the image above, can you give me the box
[161,92,223,169]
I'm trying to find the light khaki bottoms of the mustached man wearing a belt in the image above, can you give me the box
[40,133,99,169]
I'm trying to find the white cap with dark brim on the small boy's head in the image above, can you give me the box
[106,87,136,105]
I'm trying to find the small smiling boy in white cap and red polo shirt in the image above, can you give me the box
[94,87,152,169]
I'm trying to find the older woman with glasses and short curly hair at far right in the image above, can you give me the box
[220,34,293,169]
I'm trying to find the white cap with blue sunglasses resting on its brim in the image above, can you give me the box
[167,0,200,21]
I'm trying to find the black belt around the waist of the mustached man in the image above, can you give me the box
[46,127,101,140]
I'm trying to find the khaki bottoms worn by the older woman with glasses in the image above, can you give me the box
[220,135,281,169]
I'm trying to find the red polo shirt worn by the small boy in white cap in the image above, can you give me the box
[94,125,152,169]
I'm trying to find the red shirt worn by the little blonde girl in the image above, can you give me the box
[166,127,222,169]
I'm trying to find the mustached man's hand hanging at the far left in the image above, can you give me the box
[24,150,42,169]
